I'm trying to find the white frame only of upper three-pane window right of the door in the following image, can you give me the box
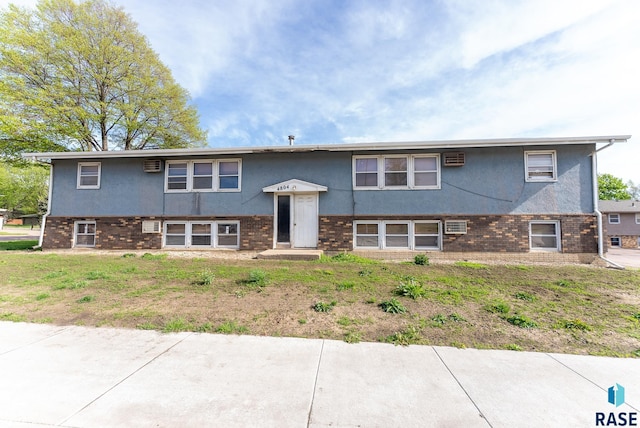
[352,153,441,190]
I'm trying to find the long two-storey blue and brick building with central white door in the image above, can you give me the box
[25,136,630,255]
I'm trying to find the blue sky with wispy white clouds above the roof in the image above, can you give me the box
[5,0,640,184]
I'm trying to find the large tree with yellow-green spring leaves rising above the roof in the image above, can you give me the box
[0,0,206,157]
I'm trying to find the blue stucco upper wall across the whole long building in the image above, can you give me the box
[51,144,594,216]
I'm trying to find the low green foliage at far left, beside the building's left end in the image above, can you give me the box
[0,162,49,215]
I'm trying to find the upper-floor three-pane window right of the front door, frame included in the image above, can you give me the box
[353,154,440,190]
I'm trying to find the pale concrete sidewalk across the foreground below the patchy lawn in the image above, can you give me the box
[0,322,640,428]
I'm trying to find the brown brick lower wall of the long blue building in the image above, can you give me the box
[43,215,596,254]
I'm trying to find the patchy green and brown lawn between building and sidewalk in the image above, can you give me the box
[0,252,640,357]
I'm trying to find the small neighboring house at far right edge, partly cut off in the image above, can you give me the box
[598,200,640,248]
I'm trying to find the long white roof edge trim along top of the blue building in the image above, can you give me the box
[22,135,631,160]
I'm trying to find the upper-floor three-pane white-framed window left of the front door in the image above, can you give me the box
[165,159,241,192]
